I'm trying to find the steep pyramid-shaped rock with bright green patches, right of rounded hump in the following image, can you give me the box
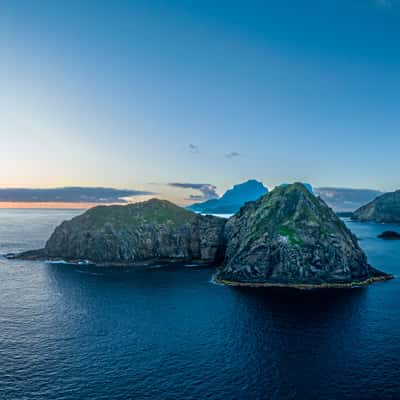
[216,183,386,285]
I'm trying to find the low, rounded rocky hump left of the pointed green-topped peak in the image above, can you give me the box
[30,199,226,264]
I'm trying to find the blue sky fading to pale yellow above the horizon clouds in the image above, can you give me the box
[0,0,400,202]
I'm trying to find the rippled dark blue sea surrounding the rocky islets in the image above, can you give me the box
[0,210,400,400]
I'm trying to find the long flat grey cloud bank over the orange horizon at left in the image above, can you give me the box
[0,187,154,203]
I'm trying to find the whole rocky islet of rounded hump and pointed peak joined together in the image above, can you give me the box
[17,183,392,288]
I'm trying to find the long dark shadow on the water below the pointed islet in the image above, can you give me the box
[223,288,374,398]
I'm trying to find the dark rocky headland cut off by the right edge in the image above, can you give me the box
[352,190,400,223]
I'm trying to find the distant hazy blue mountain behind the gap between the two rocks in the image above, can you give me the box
[188,179,268,214]
